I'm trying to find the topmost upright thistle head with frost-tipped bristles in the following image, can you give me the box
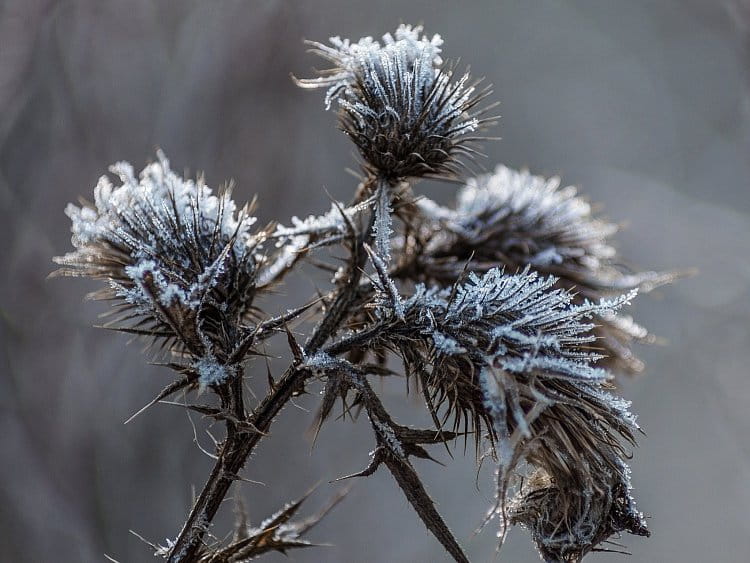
[298,25,492,180]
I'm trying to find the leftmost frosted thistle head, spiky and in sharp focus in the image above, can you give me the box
[55,153,265,384]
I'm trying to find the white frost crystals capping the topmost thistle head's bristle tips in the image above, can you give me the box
[299,24,443,109]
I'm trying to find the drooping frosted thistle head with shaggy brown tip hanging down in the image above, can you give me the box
[356,268,648,561]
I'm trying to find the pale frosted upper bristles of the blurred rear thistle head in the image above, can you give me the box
[418,165,624,284]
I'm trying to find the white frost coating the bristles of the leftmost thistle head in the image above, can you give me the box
[61,151,260,311]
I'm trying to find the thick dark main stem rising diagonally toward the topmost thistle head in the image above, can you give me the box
[167,177,383,563]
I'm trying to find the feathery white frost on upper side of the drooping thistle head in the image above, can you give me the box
[404,268,637,389]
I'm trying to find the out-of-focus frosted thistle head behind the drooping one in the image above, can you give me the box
[417,166,675,372]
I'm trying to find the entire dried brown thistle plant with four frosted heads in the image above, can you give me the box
[55,25,674,563]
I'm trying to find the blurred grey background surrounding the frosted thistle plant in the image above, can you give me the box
[0,0,750,562]
